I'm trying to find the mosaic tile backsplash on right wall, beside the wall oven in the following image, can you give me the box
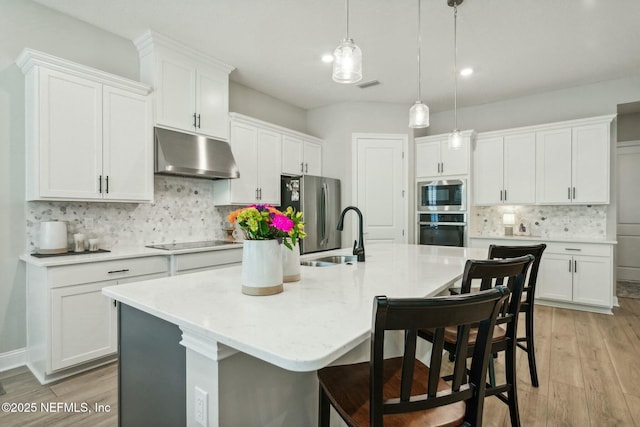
[469,205,607,239]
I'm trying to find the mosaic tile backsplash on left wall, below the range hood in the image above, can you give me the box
[26,175,233,252]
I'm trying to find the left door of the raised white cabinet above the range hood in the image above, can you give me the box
[156,56,196,132]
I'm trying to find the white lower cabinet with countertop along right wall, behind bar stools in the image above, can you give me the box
[470,237,613,313]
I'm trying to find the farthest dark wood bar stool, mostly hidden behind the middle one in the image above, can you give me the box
[489,243,547,387]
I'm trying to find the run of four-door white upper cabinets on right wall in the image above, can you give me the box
[473,116,615,205]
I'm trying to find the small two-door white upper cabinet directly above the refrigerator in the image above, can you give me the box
[282,133,322,176]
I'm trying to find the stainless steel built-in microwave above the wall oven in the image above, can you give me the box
[416,179,467,212]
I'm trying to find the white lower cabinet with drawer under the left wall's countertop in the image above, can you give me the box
[27,256,169,384]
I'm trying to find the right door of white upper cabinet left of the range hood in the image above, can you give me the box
[103,86,153,201]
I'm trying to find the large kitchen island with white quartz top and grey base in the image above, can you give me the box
[103,244,486,427]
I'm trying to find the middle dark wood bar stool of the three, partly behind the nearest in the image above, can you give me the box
[418,255,534,427]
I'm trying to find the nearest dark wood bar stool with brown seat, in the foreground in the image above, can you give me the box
[318,287,509,427]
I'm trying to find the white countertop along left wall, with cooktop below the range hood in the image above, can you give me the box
[20,243,242,267]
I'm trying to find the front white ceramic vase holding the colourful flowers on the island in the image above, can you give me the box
[242,240,284,295]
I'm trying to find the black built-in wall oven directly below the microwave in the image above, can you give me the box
[418,212,467,247]
